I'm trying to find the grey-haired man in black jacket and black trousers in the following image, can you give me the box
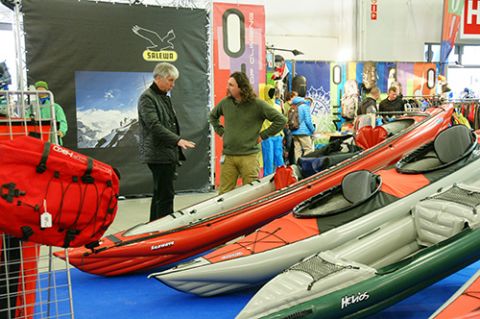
[138,63,195,221]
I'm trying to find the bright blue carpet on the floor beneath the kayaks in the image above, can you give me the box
[66,261,480,319]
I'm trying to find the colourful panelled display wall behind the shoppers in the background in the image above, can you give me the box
[290,60,438,132]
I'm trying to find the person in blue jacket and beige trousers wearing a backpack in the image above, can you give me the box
[288,96,315,163]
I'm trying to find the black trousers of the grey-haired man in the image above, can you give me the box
[148,163,177,221]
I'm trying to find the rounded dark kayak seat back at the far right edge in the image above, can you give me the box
[433,125,472,163]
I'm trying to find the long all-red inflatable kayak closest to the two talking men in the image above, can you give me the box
[56,106,453,276]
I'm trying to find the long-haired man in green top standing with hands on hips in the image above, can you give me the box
[210,72,287,194]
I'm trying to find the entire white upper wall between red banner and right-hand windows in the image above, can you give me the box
[265,0,443,61]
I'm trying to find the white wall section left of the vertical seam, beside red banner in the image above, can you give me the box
[265,0,355,60]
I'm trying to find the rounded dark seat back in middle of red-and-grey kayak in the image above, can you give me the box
[342,170,377,203]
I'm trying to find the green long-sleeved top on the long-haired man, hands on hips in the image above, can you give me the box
[210,97,287,155]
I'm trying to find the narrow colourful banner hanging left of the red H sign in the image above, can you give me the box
[440,0,465,75]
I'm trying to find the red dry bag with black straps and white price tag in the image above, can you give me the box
[0,136,119,248]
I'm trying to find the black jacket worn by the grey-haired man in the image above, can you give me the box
[138,83,185,164]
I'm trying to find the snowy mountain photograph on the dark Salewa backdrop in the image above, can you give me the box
[75,71,152,149]
